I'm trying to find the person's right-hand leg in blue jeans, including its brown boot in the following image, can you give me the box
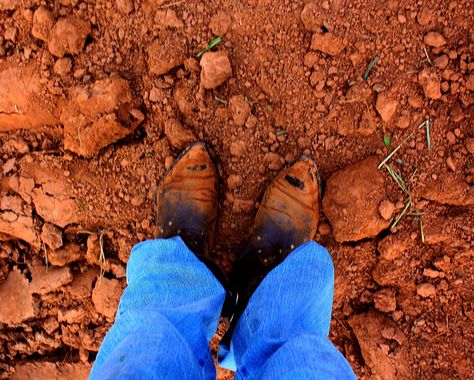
[219,158,354,379]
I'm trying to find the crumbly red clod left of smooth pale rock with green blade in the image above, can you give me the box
[146,30,186,75]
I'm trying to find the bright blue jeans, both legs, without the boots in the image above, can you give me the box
[90,237,355,380]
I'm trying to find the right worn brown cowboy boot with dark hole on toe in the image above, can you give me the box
[221,158,319,346]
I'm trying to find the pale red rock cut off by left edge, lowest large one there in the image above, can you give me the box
[0,269,34,324]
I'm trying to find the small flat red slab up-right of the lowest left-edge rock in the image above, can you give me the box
[30,263,72,294]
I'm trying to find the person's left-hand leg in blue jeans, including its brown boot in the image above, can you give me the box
[90,143,226,379]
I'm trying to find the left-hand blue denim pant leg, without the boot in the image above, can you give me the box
[90,237,225,380]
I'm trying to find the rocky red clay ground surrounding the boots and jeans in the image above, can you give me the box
[0,0,474,379]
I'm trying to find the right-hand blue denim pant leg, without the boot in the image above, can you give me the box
[219,242,355,379]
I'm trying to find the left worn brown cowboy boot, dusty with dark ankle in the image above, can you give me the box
[156,143,224,283]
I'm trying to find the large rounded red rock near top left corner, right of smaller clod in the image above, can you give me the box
[48,16,91,57]
